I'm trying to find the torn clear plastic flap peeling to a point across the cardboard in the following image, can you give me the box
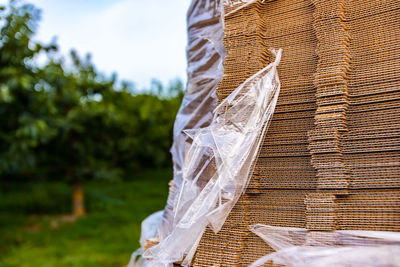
[143,50,282,266]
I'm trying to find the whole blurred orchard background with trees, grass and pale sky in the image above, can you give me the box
[0,0,189,267]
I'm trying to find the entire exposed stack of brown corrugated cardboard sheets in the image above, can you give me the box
[194,0,400,266]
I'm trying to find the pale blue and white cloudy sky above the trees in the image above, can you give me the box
[0,0,190,89]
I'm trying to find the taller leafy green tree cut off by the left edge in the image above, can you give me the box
[0,1,56,179]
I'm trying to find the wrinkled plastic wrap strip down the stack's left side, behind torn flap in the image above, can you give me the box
[159,0,224,243]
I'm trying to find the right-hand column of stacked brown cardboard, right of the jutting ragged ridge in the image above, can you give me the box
[337,1,400,231]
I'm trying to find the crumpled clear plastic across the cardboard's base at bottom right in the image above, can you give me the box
[250,224,400,267]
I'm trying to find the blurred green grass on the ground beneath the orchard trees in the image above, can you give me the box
[0,170,171,267]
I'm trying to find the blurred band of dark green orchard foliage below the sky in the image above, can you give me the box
[0,1,183,182]
